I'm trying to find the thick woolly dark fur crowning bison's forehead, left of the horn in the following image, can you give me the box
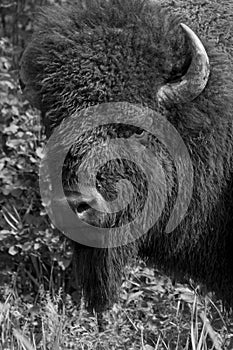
[21,0,187,114]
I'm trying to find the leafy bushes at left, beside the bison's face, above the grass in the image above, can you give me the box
[0,0,71,293]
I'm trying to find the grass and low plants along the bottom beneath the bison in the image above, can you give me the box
[0,265,233,350]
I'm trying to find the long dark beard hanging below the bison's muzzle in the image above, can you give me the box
[74,244,136,312]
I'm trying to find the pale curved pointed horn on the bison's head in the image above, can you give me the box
[157,23,210,105]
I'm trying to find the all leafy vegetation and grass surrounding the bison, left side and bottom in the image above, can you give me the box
[0,0,233,350]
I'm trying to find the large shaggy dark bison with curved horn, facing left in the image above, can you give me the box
[20,0,233,312]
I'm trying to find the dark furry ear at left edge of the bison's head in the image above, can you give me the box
[19,45,42,110]
